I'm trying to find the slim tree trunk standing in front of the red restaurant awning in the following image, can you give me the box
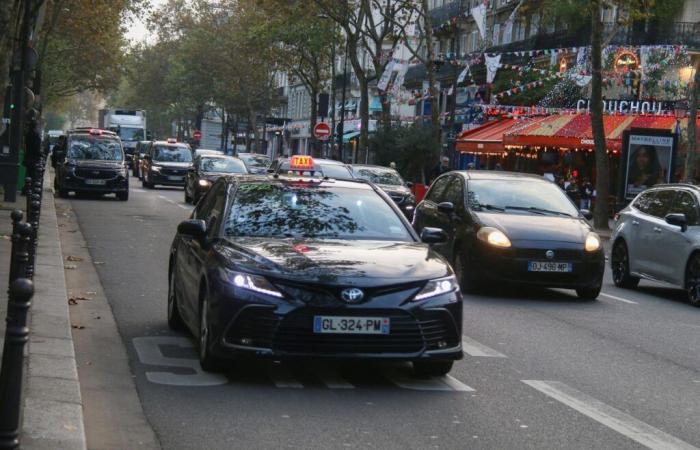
[591,0,610,230]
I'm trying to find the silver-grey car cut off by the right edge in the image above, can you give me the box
[610,184,700,307]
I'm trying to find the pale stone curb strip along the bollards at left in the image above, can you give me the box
[21,173,87,450]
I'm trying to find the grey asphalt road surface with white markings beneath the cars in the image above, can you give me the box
[64,178,700,449]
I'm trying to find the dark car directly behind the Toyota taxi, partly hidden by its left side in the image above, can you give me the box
[185,154,248,203]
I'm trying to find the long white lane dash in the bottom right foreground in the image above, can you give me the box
[522,380,698,450]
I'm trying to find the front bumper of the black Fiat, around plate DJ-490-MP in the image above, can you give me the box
[469,241,605,289]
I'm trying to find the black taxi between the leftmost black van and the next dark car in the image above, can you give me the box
[141,138,192,189]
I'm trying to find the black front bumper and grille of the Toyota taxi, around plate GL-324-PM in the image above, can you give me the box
[212,282,462,361]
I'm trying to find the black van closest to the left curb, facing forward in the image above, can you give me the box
[54,128,129,201]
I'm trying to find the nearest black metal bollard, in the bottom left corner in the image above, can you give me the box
[0,278,34,449]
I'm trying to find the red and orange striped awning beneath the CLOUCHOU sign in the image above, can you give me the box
[503,114,688,150]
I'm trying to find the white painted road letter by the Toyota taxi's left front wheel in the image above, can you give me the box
[133,336,228,386]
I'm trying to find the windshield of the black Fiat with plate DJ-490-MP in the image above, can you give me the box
[467,180,578,216]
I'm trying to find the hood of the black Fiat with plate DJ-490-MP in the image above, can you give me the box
[475,212,591,243]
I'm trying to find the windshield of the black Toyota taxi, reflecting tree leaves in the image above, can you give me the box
[225,183,413,242]
